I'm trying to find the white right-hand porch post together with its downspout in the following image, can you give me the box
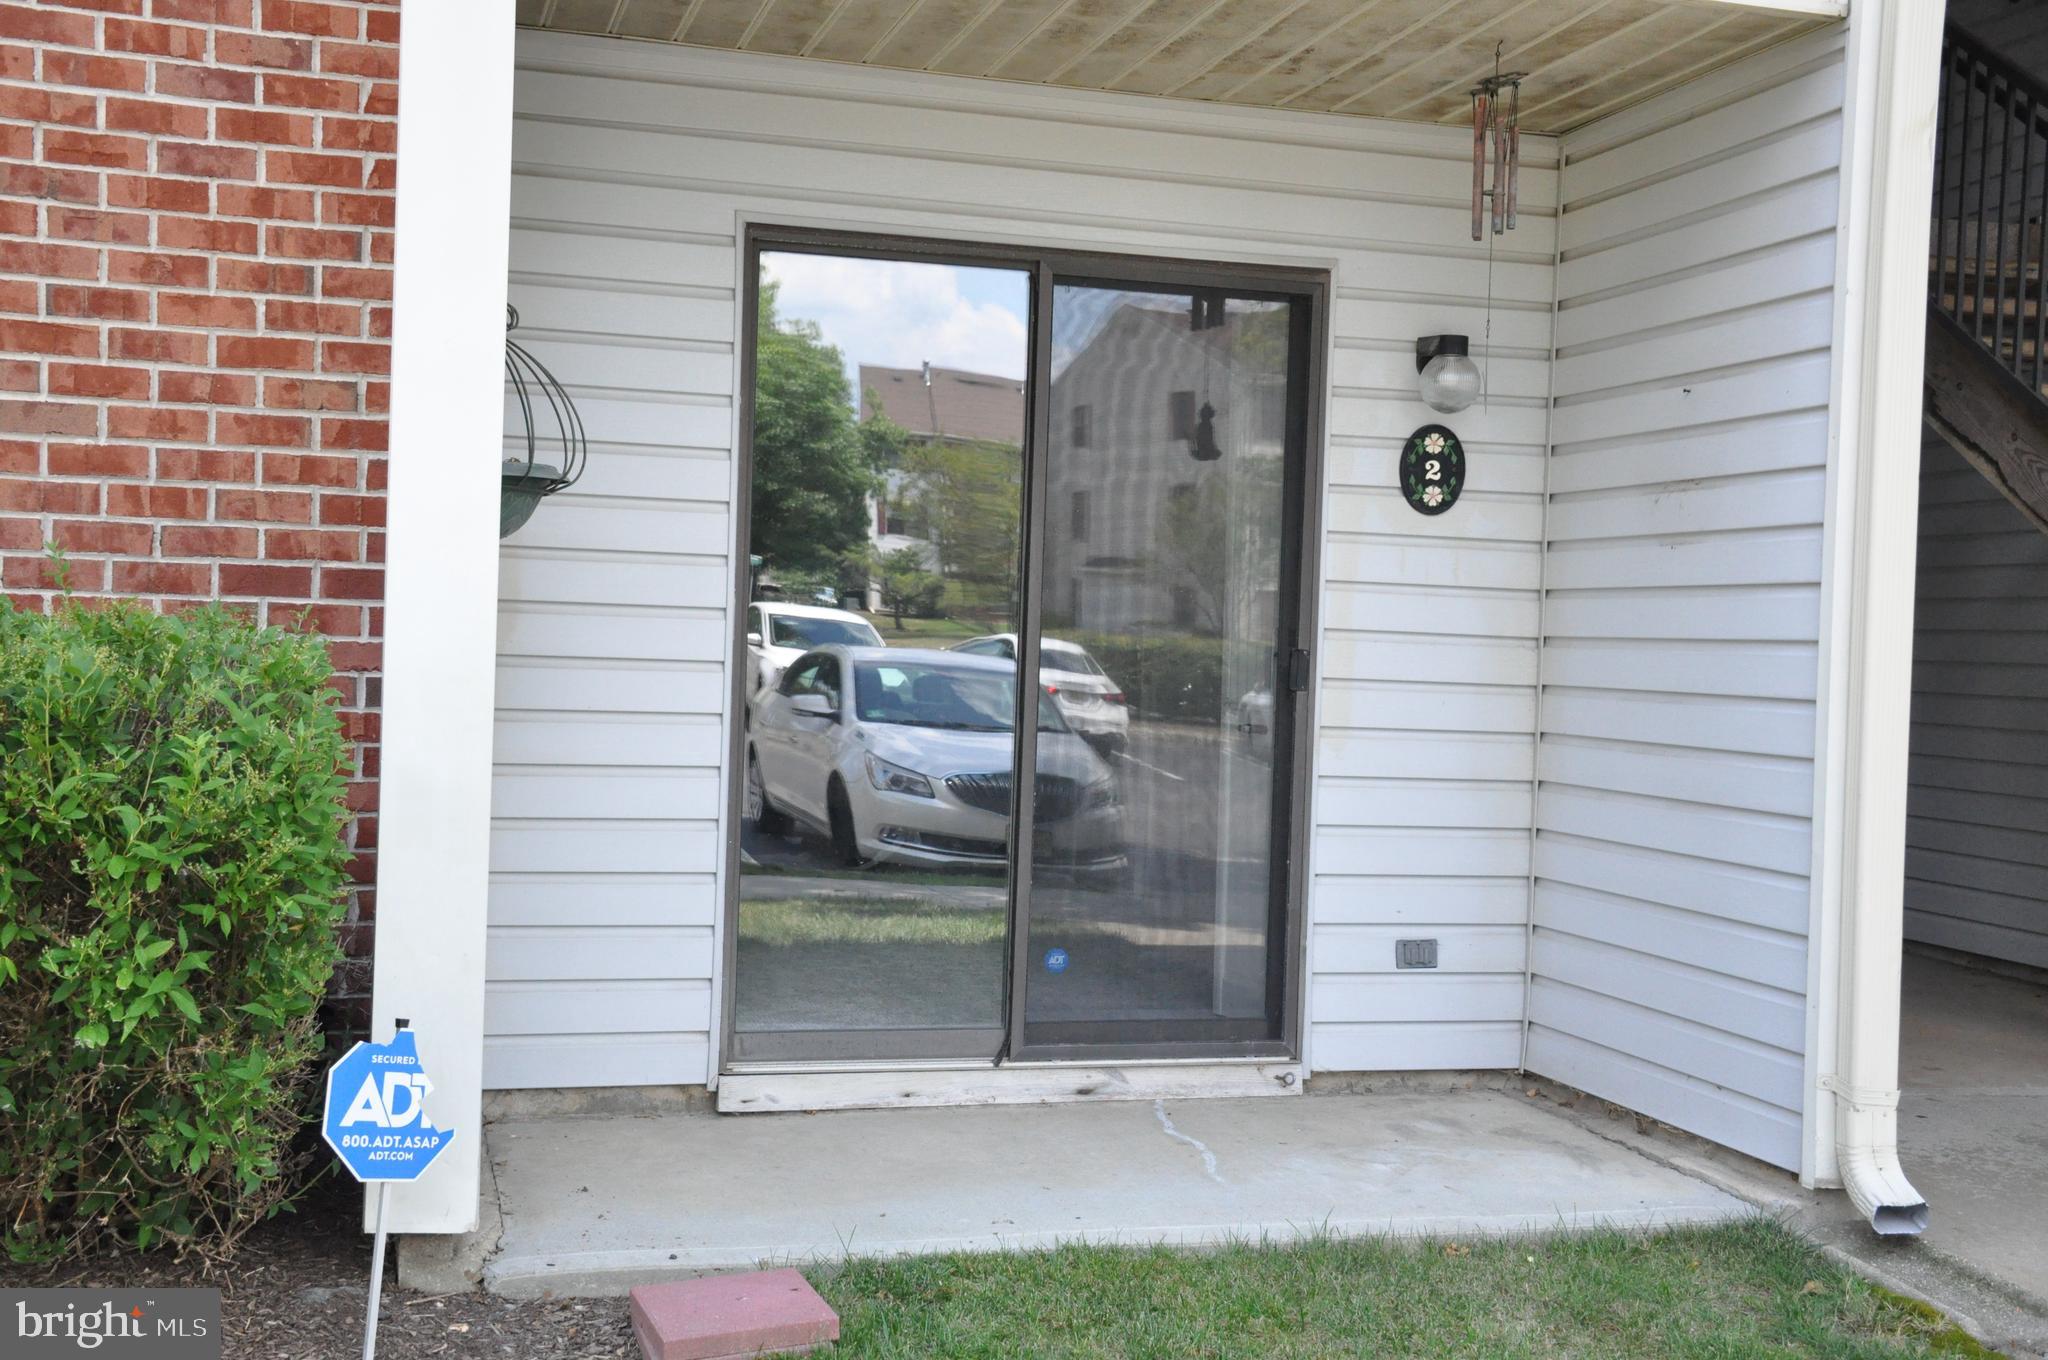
[1808,0,1944,1235]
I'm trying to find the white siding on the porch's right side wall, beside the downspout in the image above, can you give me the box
[1528,33,1843,1167]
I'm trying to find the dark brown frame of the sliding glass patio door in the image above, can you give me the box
[715,223,1329,1073]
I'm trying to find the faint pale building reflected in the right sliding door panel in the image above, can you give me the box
[1044,295,1288,637]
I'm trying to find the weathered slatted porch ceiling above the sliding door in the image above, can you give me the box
[518,0,1847,133]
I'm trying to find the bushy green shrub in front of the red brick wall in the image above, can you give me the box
[0,600,346,1260]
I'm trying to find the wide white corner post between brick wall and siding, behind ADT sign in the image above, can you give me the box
[373,0,512,1233]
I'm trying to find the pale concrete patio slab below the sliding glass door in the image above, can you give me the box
[485,1090,1755,1297]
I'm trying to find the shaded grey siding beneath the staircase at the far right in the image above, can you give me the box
[1907,434,2048,969]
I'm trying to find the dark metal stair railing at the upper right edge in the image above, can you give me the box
[1927,25,2048,393]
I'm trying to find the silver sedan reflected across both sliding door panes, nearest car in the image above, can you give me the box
[745,647,1124,868]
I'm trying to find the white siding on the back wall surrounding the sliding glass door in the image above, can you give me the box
[485,33,1556,1088]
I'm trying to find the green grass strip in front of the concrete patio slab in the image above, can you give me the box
[811,1219,1991,1360]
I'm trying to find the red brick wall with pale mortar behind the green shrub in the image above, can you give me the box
[0,0,397,1028]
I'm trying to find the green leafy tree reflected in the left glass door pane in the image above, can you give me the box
[750,279,887,584]
